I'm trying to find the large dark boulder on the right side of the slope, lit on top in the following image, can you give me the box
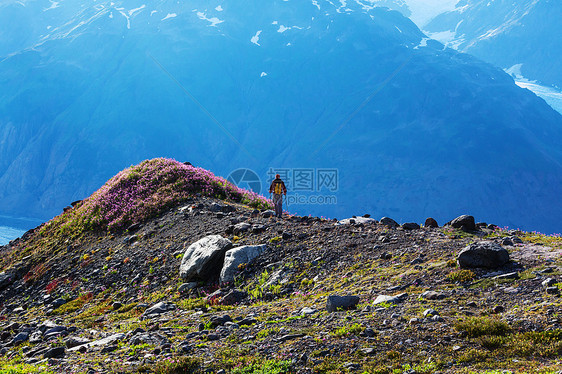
[457,241,509,269]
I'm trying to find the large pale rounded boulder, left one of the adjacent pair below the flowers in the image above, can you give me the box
[180,235,232,280]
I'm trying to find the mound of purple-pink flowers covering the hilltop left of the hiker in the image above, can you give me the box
[53,158,272,231]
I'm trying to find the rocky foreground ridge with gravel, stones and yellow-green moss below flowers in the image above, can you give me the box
[0,166,562,373]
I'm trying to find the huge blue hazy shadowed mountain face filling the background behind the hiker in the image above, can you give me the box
[0,0,562,232]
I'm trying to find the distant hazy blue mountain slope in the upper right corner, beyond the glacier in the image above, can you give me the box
[424,0,562,87]
